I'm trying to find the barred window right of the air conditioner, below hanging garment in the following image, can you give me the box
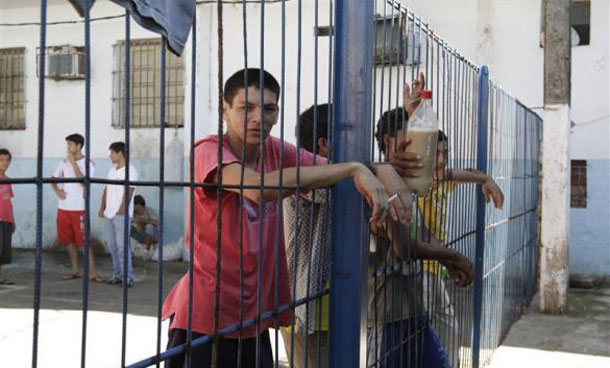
[112,39,184,128]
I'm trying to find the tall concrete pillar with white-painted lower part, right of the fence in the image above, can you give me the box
[540,0,571,313]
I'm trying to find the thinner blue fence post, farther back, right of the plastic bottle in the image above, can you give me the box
[472,66,489,368]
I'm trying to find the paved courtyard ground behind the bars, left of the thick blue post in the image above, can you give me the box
[0,250,285,368]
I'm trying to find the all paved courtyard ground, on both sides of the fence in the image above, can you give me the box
[0,250,610,368]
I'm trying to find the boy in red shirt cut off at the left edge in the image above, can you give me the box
[0,148,16,285]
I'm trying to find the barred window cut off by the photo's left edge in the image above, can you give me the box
[0,47,25,130]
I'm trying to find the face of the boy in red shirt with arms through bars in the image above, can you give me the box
[223,87,279,145]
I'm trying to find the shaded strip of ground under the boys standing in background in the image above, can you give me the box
[0,249,188,316]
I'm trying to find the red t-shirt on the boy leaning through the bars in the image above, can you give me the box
[163,135,326,338]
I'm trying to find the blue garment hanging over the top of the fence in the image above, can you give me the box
[110,0,196,56]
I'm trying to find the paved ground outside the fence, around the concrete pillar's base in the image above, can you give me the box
[488,283,610,368]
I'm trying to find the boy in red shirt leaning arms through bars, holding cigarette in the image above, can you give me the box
[163,69,406,368]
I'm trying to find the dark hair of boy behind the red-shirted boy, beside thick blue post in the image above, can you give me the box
[296,104,332,153]
